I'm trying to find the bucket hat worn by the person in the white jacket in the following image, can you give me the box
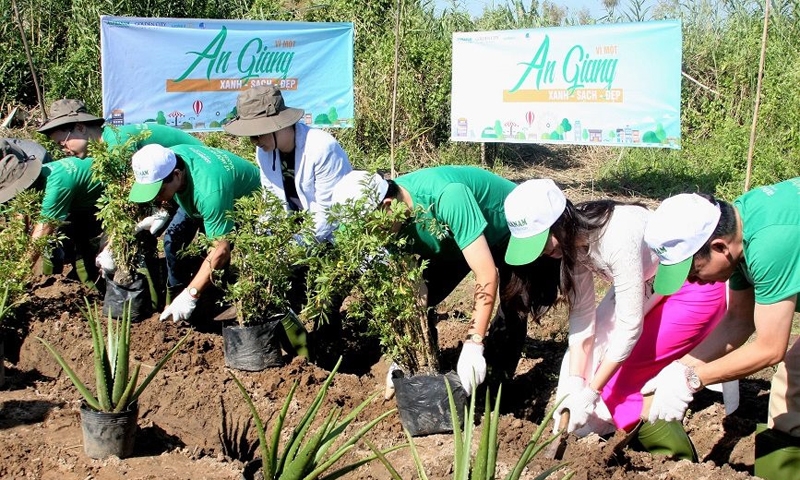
[223,85,304,137]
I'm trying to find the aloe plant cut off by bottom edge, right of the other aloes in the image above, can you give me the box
[370,379,575,480]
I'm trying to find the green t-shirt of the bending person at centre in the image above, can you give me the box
[395,166,516,259]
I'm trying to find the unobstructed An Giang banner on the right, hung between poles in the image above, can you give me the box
[450,20,681,149]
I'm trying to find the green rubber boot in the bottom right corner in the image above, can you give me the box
[754,423,800,480]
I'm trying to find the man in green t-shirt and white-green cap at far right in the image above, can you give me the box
[644,177,800,480]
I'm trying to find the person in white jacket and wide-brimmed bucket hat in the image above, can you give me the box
[223,85,352,240]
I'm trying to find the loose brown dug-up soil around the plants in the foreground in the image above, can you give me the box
[0,148,772,480]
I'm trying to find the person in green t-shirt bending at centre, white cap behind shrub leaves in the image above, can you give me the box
[333,166,527,394]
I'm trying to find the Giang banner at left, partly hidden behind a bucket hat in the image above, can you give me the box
[100,16,354,131]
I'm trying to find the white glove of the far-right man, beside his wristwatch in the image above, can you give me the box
[641,360,694,422]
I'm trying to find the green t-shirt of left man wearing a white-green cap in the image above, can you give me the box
[171,145,261,238]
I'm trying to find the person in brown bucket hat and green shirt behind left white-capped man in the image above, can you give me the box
[37,98,203,158]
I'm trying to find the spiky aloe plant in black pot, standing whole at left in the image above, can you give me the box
[36,300,191,458]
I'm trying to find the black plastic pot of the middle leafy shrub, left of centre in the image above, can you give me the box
[222,317,283,372]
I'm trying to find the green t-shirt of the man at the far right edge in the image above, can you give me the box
[730,177,800,311]
